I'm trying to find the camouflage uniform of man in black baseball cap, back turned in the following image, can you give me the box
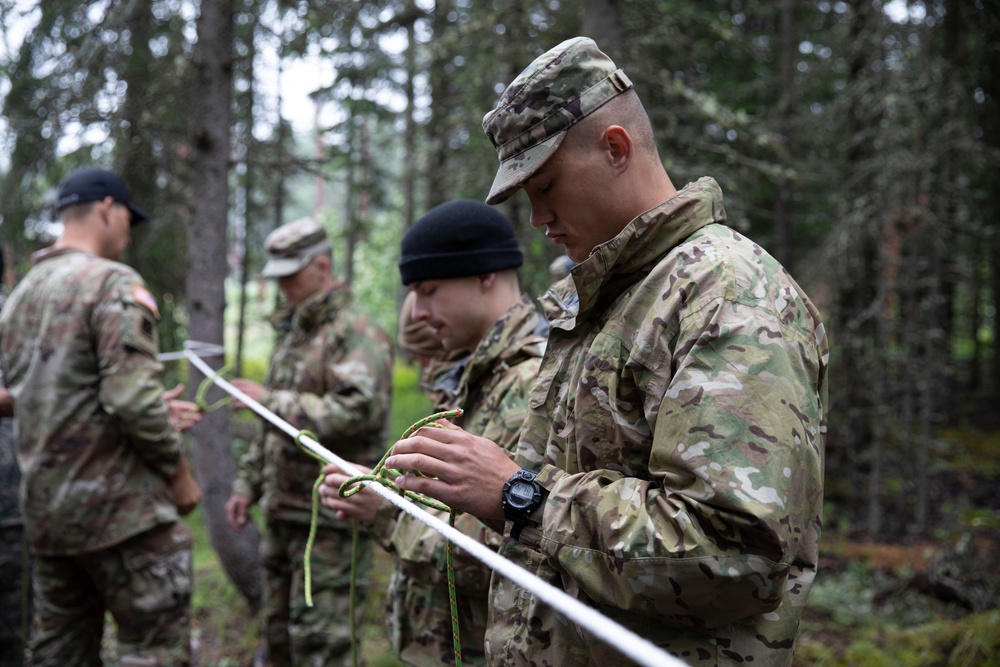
[0,249,191,665]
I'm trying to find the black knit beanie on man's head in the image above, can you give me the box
[399,199,524,285]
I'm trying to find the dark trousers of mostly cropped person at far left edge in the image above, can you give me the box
[0,526,31,667]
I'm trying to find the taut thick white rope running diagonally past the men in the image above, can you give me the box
[184,348,687,667]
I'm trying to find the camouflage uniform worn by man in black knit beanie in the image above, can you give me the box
[375,296,548,666]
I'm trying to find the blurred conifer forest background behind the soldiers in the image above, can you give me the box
[0,0,1000,664]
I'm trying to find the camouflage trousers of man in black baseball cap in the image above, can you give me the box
[28,523,192,667]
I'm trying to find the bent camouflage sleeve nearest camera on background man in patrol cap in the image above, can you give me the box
[261,317,392,458]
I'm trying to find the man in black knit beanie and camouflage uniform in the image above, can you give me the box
[321,199,548,665]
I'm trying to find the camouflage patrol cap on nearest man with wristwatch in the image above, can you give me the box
[483,37,632,204]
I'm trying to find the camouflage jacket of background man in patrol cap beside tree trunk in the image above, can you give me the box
[233,282,392,529]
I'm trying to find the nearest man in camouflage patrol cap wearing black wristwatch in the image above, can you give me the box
[376,37,828,667]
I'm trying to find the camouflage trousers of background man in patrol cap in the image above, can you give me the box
[261,521,372,667]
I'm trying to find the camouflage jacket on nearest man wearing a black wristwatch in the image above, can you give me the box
[487,178,828,667]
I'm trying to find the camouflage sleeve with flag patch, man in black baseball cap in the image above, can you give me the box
[92,271,181,479]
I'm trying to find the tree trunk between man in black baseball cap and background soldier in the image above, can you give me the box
[187,0,261,608]
